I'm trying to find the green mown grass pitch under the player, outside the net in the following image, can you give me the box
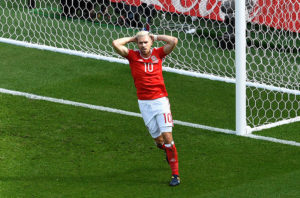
[0,43,300,198]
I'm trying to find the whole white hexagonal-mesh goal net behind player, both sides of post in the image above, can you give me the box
[0,0,300,135]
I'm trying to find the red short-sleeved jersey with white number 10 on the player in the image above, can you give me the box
[126,47,168,100]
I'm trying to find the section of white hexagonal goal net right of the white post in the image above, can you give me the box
[247,0,300,127]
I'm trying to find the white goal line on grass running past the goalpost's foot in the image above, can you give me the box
[0,88,300,147]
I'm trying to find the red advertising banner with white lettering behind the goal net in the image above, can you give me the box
[111,0,300,32]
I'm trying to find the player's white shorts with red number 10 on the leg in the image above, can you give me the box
[138,97,174,138]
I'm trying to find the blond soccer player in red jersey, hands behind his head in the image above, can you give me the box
[112,31,180,186]
